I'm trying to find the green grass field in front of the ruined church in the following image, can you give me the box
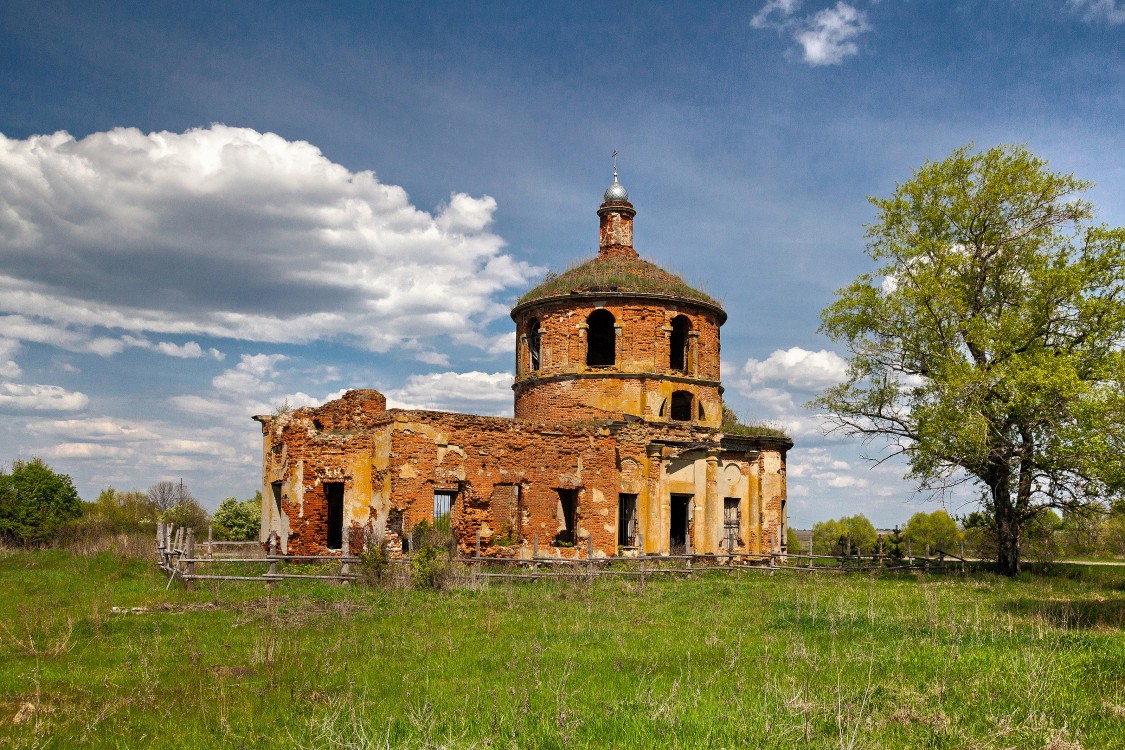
[0,551,1125,750]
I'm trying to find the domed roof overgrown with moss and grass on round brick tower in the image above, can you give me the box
[516,255,721,308]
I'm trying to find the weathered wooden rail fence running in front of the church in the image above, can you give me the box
[156,524,969,589]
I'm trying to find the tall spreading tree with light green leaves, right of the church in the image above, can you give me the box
[815,146,1125,575]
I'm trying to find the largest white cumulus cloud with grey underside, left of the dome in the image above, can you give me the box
[0,125,538,359]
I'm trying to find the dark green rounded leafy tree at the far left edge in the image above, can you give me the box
[0,459,82,544]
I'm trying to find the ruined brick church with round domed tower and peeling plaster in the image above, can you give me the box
[254,170,793,558]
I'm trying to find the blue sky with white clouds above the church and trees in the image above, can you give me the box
[0,0,1125,526]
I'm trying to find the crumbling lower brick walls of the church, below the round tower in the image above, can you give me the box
[262,393,788,558]
